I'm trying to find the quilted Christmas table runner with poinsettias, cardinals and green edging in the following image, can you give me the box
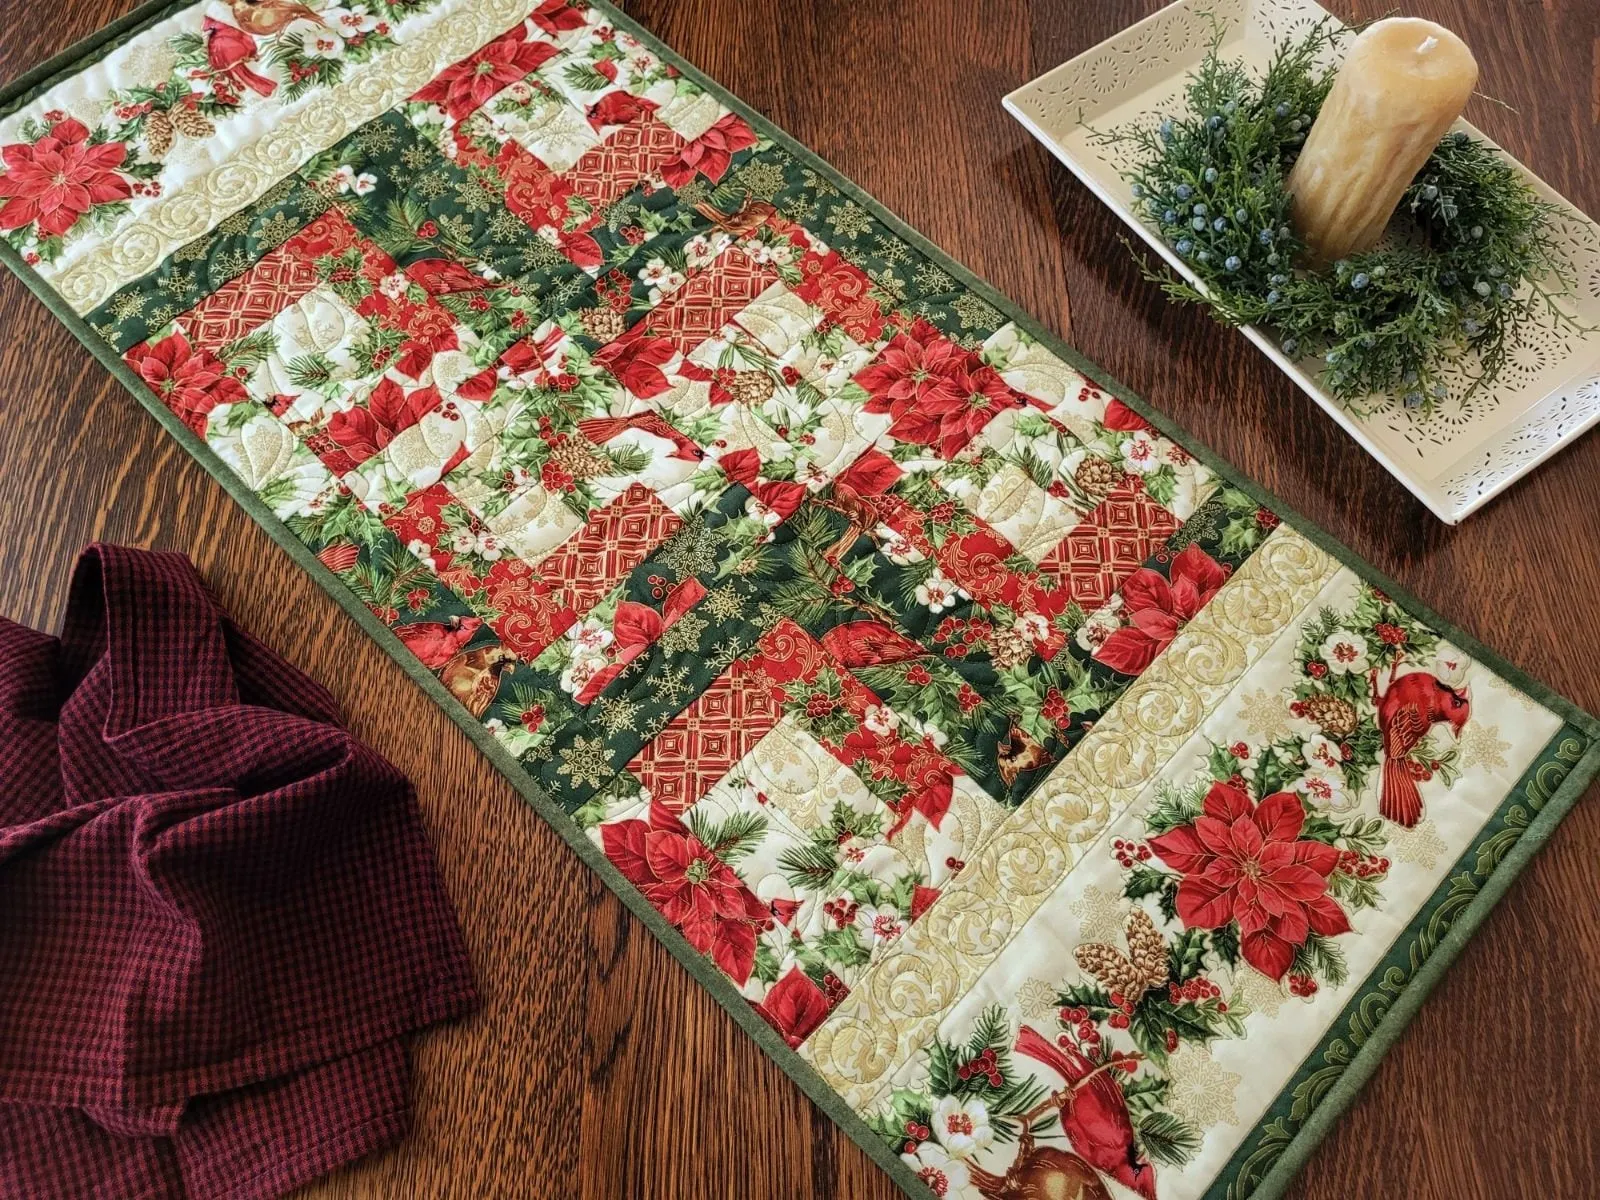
[0,0,1600,1200]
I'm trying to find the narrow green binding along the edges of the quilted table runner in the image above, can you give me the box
[0,0,1600,1200]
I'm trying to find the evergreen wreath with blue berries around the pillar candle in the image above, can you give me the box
[1098,21,1574,413]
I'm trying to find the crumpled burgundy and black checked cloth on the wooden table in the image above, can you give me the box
[0,546,475,1200]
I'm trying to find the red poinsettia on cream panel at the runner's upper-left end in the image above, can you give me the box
[0,120,133,237]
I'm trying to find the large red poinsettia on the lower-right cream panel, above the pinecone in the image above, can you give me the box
[1150,782,1350,979]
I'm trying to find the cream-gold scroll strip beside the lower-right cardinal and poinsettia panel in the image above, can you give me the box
[800,525,1339,1110]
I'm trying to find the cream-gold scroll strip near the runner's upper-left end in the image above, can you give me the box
[46,0,538,314]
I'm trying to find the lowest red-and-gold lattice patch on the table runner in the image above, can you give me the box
[627,659,782,814]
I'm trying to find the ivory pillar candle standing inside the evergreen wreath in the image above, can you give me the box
[1288,18,1478,262]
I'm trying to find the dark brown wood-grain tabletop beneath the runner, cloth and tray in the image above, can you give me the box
[0,0,1600,1200]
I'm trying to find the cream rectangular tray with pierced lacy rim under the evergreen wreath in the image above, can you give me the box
[1005,0,1600,525]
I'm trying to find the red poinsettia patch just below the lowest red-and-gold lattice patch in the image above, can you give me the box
[600,805,773,986]
